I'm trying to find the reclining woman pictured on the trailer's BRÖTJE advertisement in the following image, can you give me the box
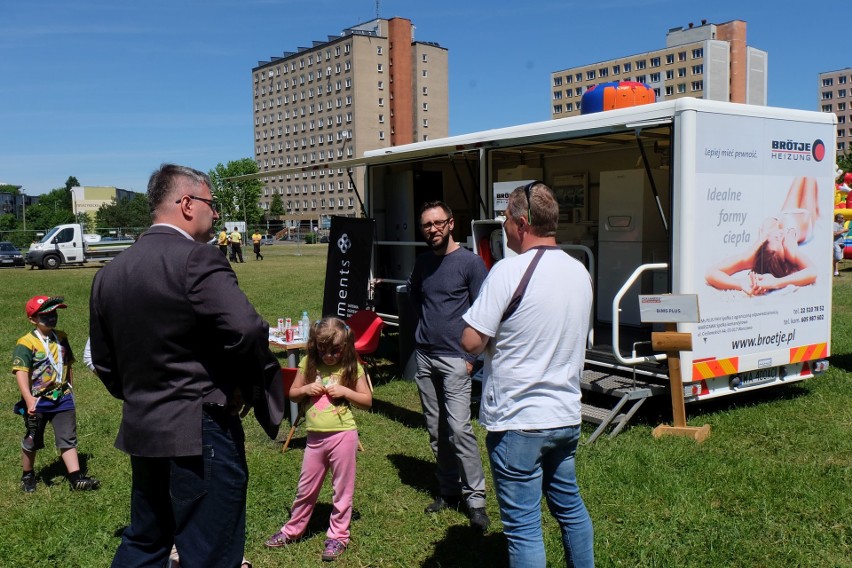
[705,177,819,296]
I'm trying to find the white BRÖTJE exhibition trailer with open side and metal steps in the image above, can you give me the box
[359,98,836,435]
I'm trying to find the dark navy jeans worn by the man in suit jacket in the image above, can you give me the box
[112,413,248,568]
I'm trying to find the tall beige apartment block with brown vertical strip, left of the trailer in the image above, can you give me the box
[252,18,449,226]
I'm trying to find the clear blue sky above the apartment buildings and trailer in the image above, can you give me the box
[0,0,852,194]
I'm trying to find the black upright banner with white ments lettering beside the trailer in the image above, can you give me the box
[322,217,376,319]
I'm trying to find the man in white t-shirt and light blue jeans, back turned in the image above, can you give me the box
[462,182,594,568]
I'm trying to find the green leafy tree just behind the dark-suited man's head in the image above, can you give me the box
[208,158,263,228]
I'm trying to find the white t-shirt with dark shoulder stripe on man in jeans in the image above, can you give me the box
[463,249,592,432]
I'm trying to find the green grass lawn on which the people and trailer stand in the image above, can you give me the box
[0,244,852,568]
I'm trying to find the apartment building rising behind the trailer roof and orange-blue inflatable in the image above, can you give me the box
[551,20,768,118]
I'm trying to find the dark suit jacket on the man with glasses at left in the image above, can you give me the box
[89,225,284,457]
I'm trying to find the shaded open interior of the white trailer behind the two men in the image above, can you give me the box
[367,124,673,440]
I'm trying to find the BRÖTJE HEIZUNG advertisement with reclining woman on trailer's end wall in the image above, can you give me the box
[685,113,834,371]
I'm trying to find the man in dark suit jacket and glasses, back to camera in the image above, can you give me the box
[90,164,284,568]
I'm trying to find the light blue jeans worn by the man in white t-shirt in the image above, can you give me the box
[485,426,595,568]
